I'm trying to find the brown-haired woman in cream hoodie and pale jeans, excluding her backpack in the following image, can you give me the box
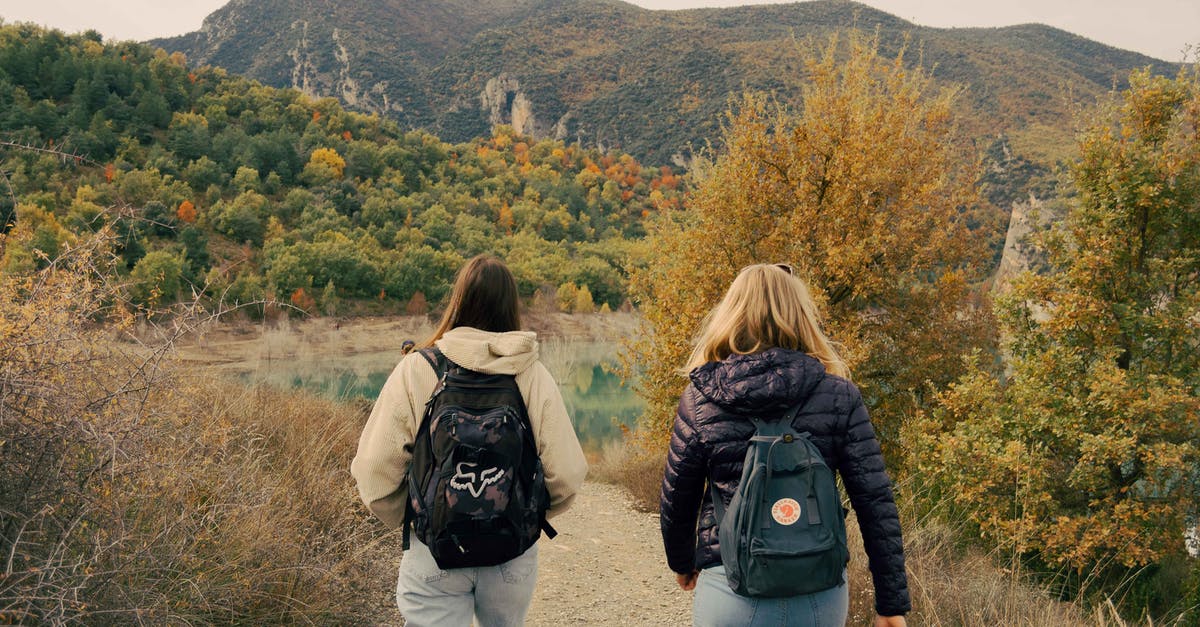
[350,255,587,627]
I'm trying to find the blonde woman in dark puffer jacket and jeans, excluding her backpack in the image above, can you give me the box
[660,264,911,627]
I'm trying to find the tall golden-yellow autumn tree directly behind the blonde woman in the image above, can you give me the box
[628,32,988,454]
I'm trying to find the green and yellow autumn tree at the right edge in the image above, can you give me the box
[912,72,1200,590]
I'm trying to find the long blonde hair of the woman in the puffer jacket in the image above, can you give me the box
[685,264,850,378]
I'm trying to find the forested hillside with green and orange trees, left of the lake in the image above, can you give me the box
[0,25,680,314]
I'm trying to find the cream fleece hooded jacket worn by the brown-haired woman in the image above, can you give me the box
[350,327,588,527]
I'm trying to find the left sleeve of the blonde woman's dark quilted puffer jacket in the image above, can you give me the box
[659,386,708,574]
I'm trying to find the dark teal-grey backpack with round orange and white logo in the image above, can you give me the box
[712,406,850,597]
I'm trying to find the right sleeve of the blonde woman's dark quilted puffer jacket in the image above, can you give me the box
[838,387,912,616]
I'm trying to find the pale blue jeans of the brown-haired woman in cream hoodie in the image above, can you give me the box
[396,538,538,627]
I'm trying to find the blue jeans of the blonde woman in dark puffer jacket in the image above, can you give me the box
[691,566,850,627]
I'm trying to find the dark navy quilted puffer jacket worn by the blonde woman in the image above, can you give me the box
[660,348,911,616]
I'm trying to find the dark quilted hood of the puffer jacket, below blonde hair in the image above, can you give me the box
[690,348,826,414]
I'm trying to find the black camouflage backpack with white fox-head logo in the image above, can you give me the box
[403,347,556,568]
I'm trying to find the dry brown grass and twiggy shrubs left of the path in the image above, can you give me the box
[0,233,391,625]
